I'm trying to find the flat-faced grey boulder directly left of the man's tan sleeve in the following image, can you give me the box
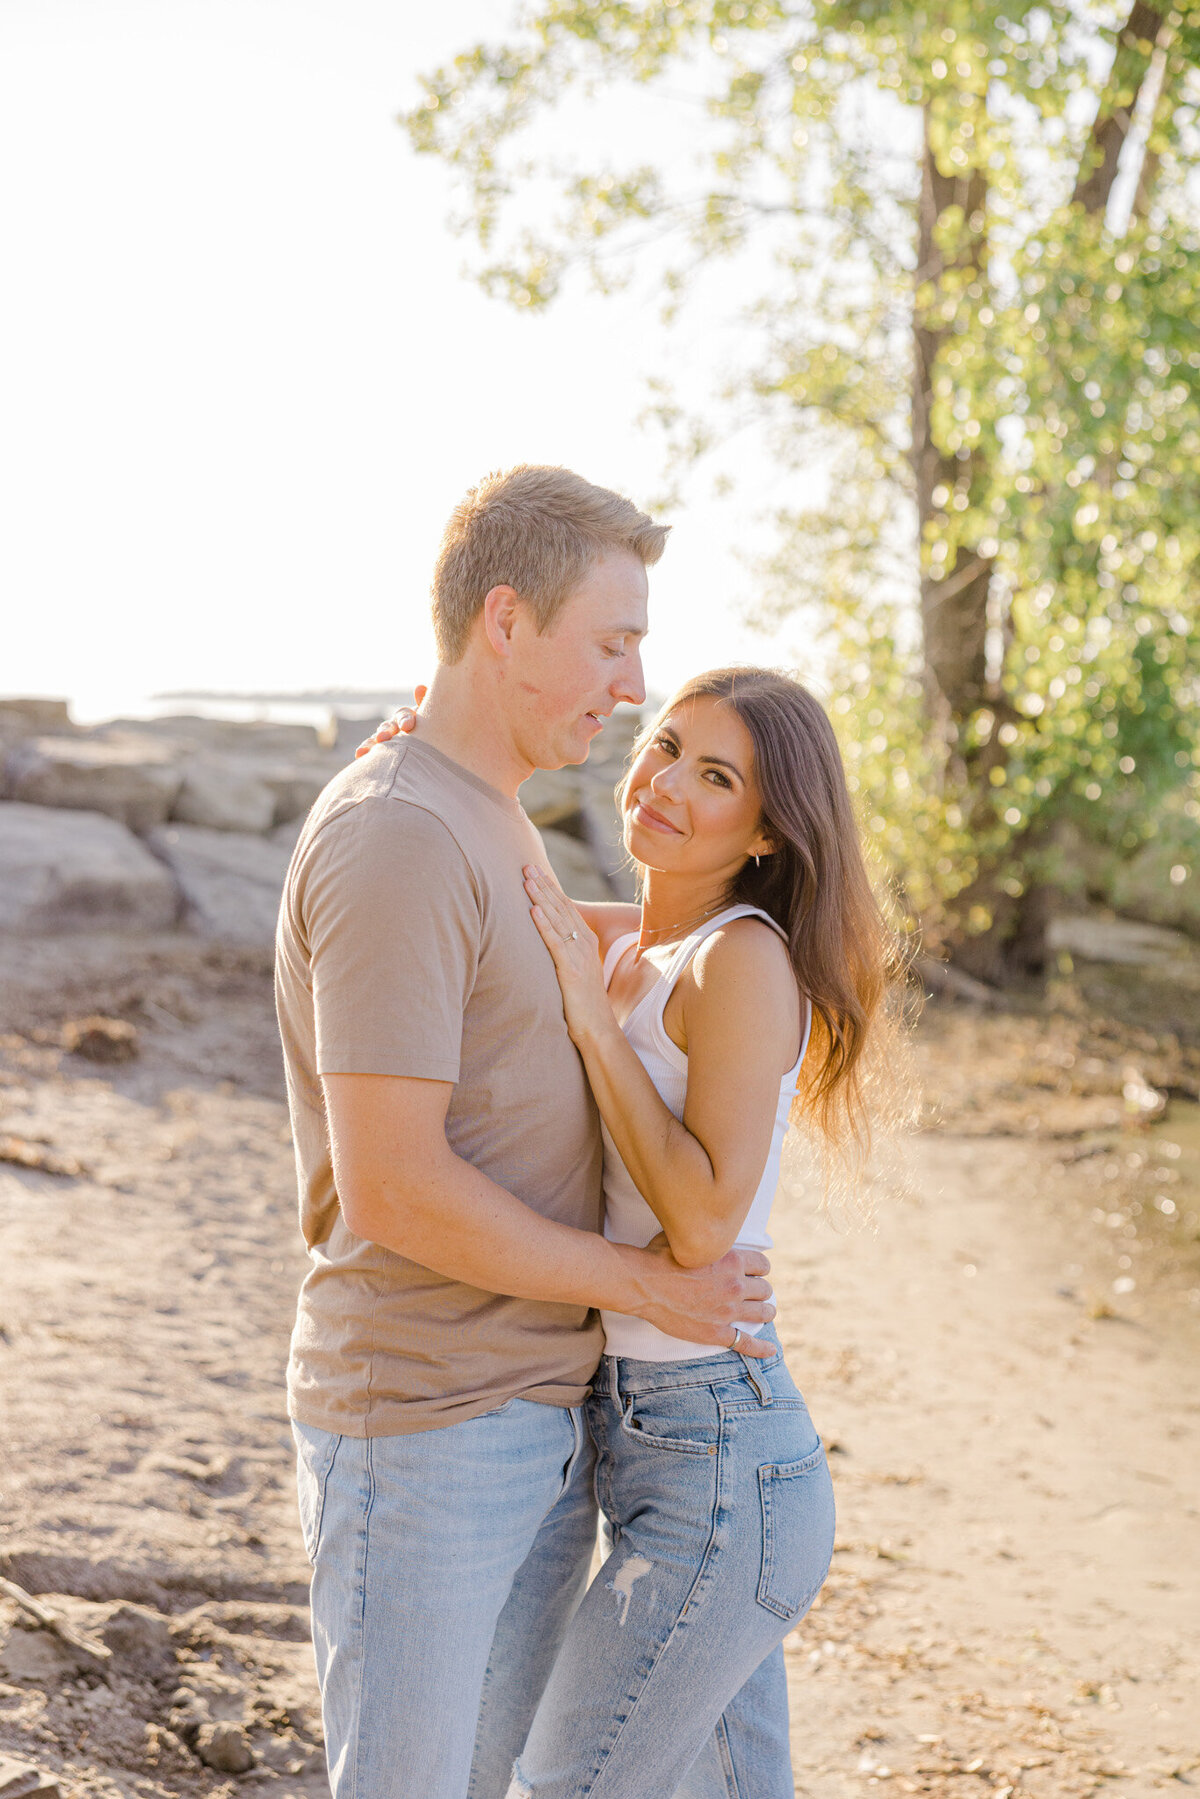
[151,824,291,948]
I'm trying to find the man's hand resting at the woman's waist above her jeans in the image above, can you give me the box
[618,1232,775,1358]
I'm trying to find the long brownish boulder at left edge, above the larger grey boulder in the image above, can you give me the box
[4,732,184,831]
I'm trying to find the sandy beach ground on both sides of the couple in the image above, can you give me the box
[0,939,1200,1799]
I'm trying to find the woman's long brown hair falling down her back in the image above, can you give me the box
[635,667,910,1193]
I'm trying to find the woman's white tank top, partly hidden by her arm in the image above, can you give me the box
[601,905,813,1362]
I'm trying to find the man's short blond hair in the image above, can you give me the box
[434,462,671,662]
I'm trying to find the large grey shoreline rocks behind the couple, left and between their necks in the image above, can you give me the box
[0,700,639,950]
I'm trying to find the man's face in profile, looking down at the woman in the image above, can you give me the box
[507,550,648,768]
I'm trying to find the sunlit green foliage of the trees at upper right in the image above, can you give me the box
[407,0,1200,939]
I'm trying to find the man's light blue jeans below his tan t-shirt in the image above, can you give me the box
[291,1400,596,1799]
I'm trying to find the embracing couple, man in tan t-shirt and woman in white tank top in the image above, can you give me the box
[277,468,887,1799]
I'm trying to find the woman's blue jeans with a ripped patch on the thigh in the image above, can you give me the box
[509,1351,833,1799]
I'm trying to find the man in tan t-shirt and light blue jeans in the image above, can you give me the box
[277,468,774,1799]
